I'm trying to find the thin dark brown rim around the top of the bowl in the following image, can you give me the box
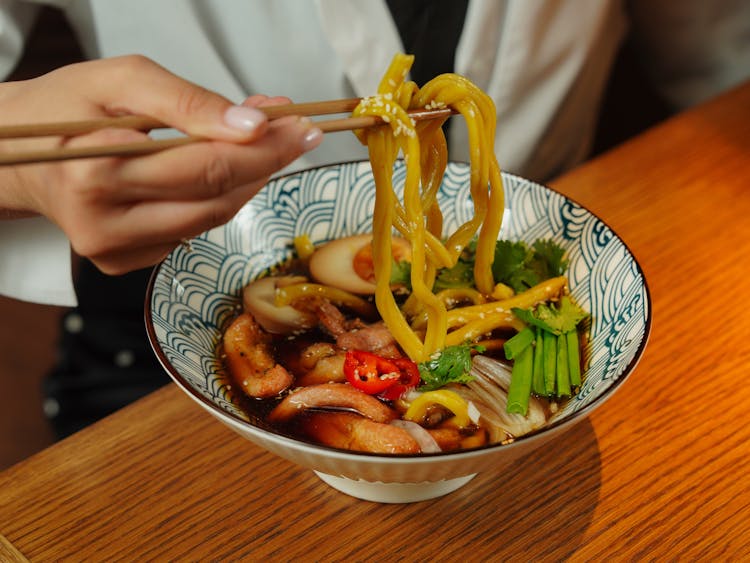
[143,159,653,463]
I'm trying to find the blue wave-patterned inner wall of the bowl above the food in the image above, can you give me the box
[151,162,650,438]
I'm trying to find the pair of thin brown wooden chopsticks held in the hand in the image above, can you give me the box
[0,98,453,165]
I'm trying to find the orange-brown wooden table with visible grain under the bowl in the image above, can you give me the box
[0,84,750,561]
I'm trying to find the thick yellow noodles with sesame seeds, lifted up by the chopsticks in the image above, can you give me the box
[353,54,504,362]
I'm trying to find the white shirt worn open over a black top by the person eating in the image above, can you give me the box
[0,0,748,305]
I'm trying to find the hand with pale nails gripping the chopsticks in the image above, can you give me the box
[0,56,322,274]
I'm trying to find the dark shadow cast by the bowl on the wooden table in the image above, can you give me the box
[308,419,601,561]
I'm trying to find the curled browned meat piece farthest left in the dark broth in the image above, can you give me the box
[224,313,294,398]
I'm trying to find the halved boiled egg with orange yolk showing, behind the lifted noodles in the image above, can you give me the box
[309,234,411,295]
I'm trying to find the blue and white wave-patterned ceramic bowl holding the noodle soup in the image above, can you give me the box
[145,162,651,502]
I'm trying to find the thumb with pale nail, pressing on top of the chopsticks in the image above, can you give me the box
[79,55,268,142]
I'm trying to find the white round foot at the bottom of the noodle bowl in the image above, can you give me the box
[315,471,476,504]
